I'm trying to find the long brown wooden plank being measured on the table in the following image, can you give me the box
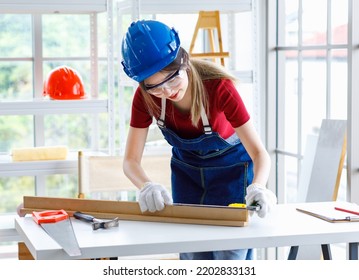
[20,196,248,226]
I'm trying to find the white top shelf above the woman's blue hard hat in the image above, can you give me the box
[117,0,252,14]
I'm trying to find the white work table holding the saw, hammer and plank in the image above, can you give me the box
[15,202,359,260]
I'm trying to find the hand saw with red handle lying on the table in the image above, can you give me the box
[32,210,81,257]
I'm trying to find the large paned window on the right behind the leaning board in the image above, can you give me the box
[269,0,351,202]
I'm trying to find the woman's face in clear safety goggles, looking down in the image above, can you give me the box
[144,68,188,102]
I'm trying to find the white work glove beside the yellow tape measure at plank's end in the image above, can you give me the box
[245,183,277,218]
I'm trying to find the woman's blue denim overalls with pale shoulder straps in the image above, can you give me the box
[157,98,253,259]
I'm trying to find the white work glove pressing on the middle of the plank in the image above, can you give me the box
[138,182,173,212]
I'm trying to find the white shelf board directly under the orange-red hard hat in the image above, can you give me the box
[0,99,109,115]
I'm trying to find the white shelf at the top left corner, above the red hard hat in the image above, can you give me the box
[0,0,107,14]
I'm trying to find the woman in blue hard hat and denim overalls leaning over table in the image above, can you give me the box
[122,20,276,259]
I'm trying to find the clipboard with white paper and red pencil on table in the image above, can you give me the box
[296,202,359,223]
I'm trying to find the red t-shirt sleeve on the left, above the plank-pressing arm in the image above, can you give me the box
[130,88,152,128]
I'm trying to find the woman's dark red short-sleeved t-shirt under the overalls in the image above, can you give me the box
[130,79,250,139]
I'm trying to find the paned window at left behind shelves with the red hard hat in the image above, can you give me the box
[0,1,114,213]
